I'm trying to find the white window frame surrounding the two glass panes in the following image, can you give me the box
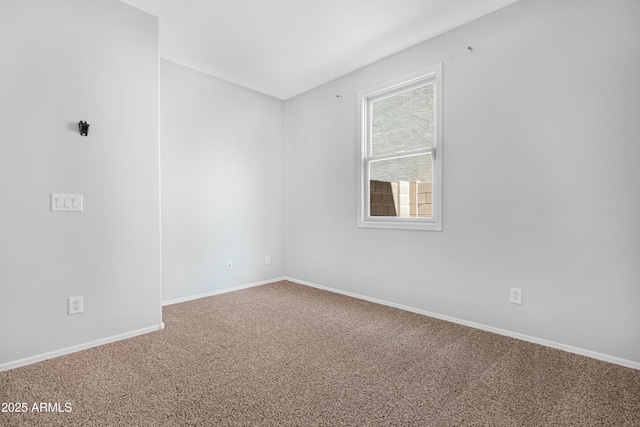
[357,64,442,231]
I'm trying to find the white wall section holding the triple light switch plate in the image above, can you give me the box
[0,0,162,370]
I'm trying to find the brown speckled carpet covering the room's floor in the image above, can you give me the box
[0,282,640,427]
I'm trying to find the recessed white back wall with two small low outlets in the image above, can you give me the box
[161,60,284,302]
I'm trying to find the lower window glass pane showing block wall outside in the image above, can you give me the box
[369,153,433,218]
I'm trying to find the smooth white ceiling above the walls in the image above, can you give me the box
[122,0,517,99]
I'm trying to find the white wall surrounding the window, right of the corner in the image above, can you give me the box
[285,0,640,364]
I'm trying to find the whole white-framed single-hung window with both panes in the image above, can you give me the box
[358,64,442,230]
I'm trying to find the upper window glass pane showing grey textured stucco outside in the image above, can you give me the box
[371,83,434,156]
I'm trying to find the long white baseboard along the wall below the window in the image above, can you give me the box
[284,277,640,370]
